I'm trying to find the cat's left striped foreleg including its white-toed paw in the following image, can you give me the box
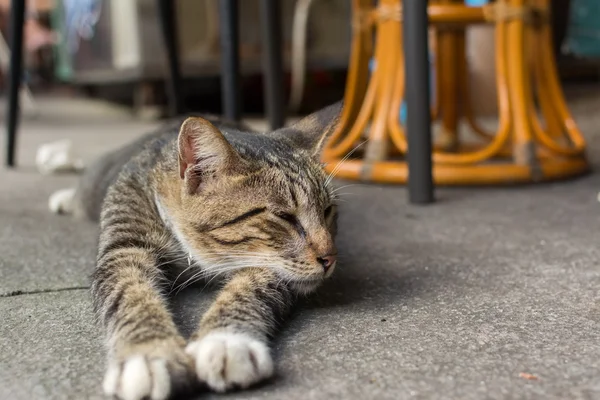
[92,246,195,400]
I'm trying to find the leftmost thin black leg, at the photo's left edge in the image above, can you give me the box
[6,0,25,167]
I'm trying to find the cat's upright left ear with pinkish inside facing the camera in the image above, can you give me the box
[177,117,241,193]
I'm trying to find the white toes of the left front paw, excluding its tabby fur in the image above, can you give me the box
[102,355,171,400]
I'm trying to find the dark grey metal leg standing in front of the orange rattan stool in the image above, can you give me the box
[402,0,434,204]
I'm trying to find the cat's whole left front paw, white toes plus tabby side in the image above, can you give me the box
[102,349,194,400]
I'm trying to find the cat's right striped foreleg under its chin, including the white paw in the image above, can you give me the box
[186,268,293,392]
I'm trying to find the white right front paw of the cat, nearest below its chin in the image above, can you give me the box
[186,332,273,392]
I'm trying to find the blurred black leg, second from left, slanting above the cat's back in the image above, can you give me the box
[158,0,184,115]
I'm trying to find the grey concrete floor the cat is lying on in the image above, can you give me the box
[0,90,600,400]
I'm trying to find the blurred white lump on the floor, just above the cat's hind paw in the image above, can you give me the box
[35,140,83,175]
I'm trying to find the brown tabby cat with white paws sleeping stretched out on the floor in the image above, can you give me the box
[51,102,342,400]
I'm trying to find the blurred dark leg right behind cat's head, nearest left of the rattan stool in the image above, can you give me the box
[260,0,285,129]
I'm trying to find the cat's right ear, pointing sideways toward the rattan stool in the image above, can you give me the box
[272,101,343,157]
